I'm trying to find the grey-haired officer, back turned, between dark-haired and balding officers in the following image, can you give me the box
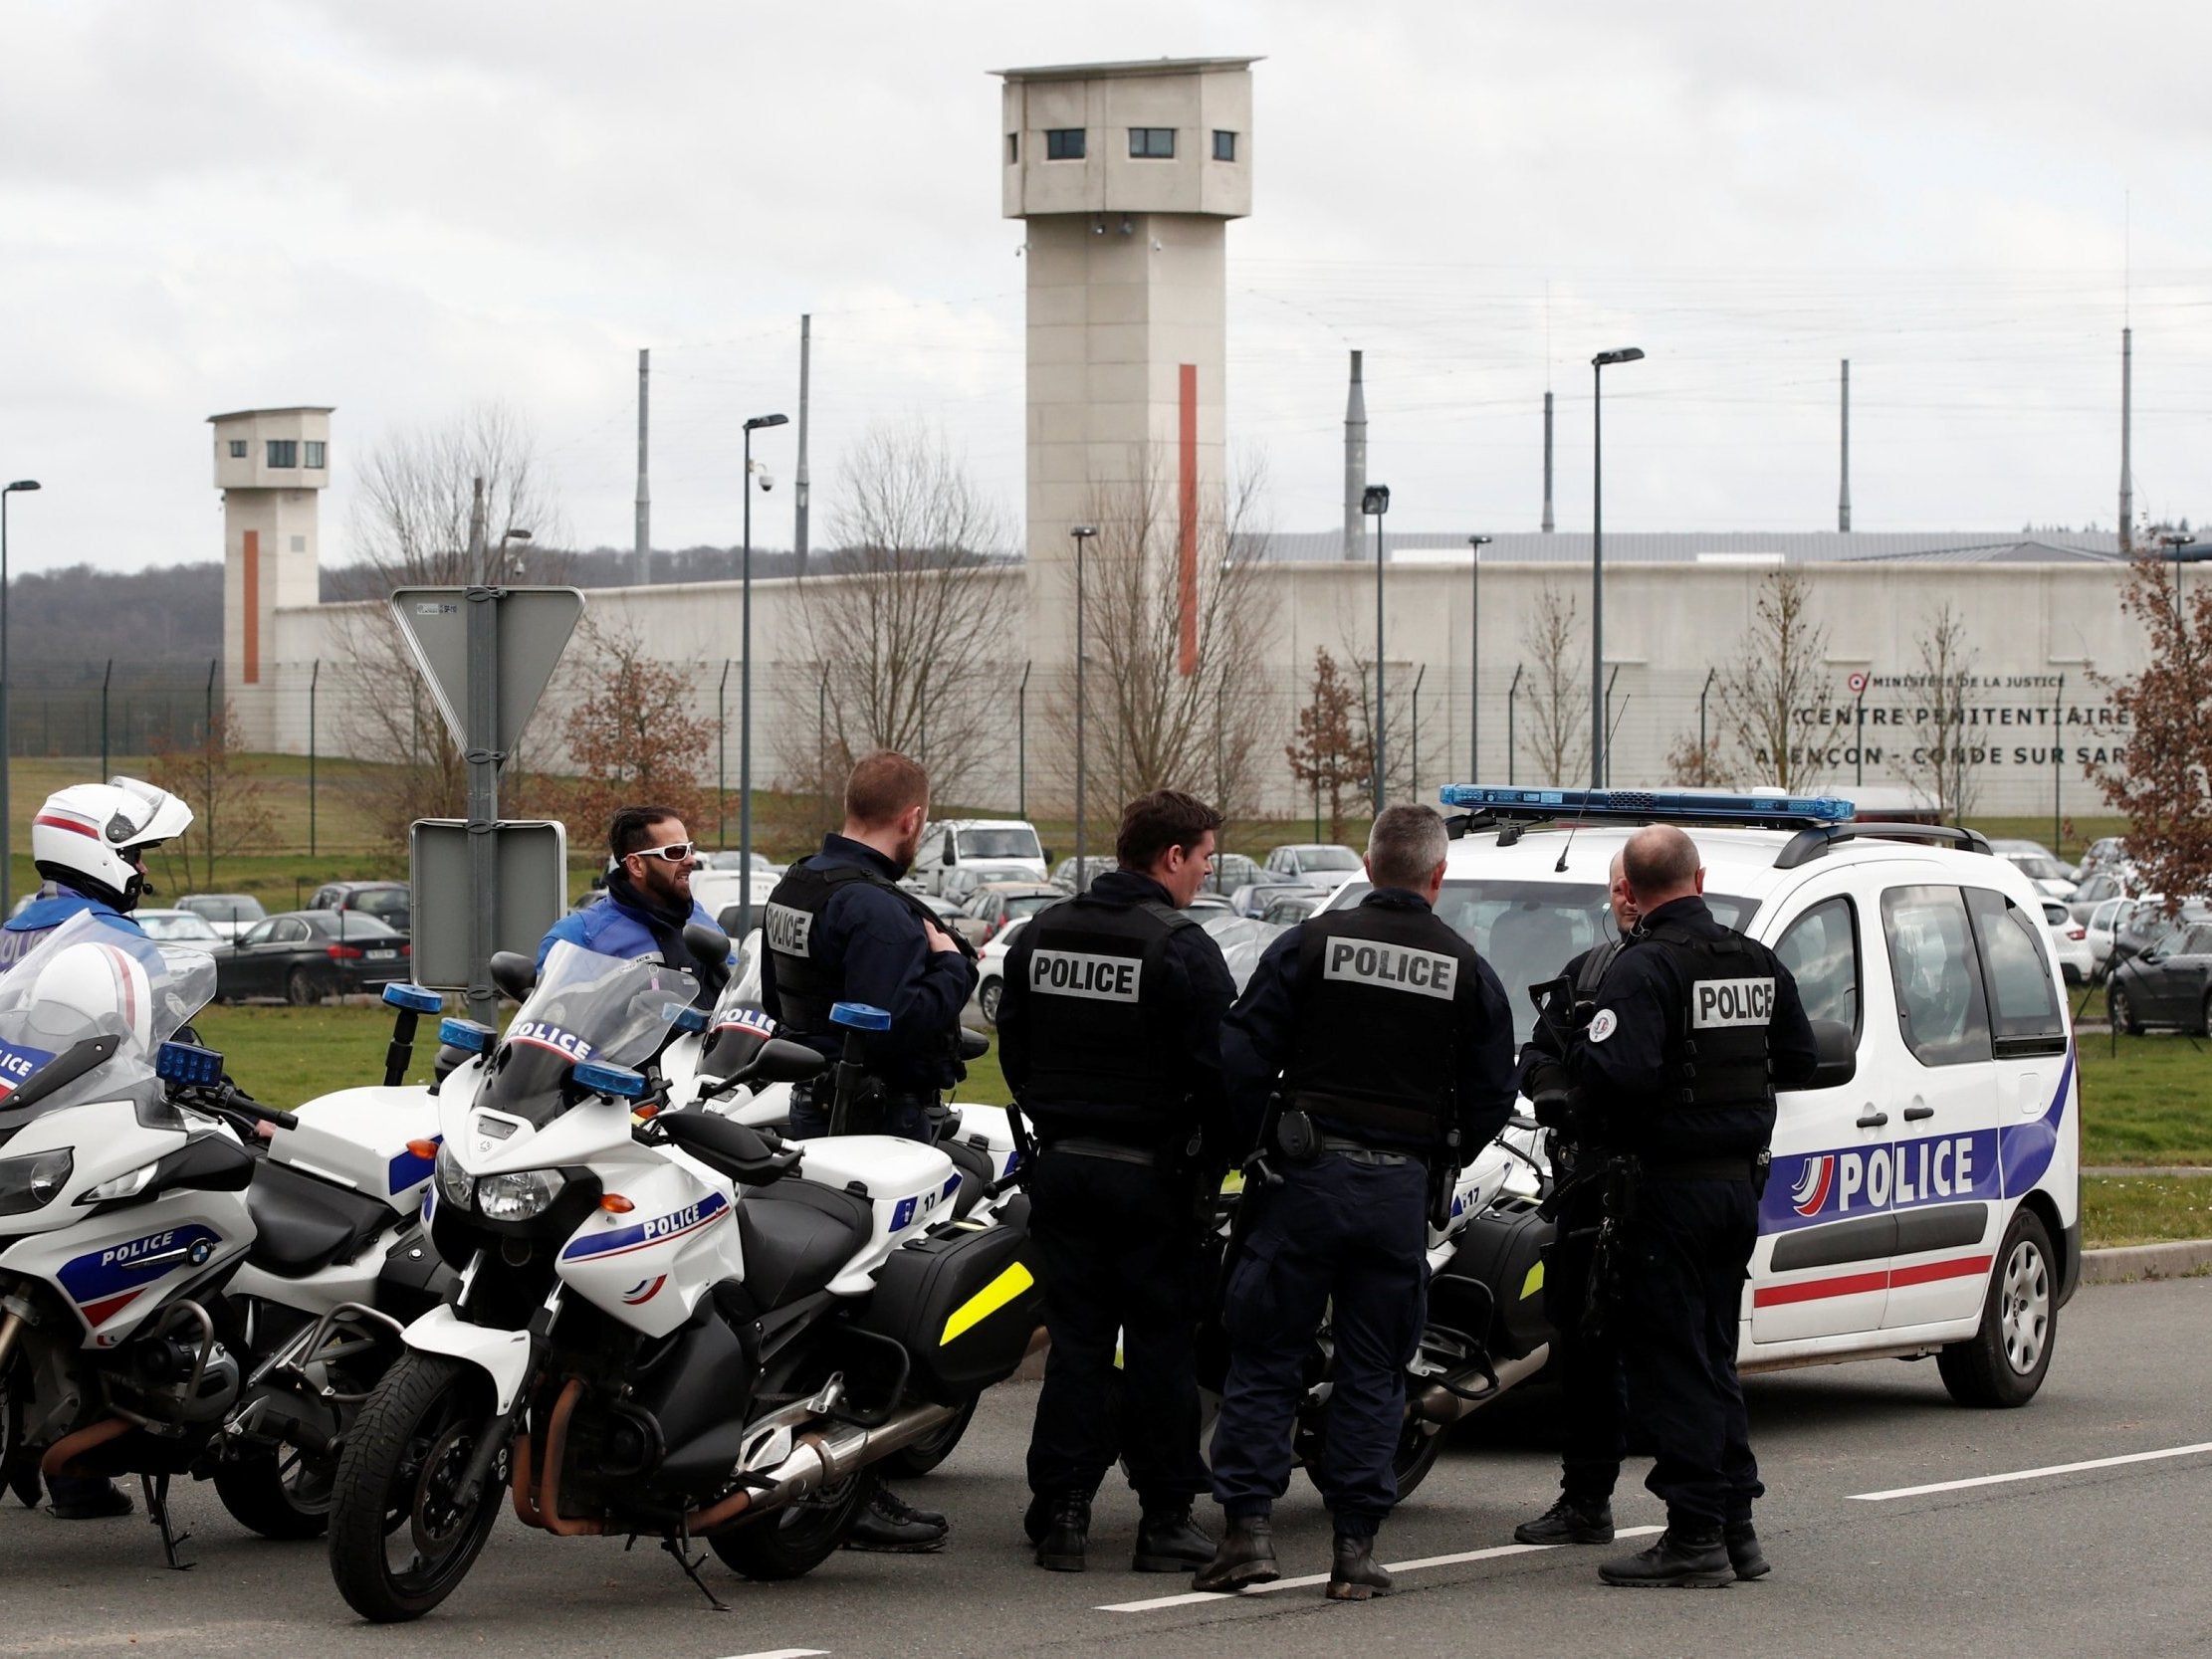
[1193,805,1513,1601]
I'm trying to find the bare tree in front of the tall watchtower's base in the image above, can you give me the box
[1048,458,1281,816]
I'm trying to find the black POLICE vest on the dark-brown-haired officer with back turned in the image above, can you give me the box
[1022,894,1195,1131]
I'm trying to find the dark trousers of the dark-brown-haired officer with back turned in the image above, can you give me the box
[1028,1148,1206,1511]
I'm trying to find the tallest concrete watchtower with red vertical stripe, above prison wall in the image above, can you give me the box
[999,58,1258,673]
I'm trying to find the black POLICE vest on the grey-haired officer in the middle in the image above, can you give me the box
[1285,905,1480,1143]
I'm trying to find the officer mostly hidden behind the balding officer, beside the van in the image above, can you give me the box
[1513,854,1637,1544]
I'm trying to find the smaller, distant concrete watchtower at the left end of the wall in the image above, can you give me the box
[208,407,330,749]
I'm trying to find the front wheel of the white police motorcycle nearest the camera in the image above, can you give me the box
[330,1351,509,1623]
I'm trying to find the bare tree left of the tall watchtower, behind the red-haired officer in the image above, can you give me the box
[780,425,1013,798]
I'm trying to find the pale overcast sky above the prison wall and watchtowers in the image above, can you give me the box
[0,0,2212,568]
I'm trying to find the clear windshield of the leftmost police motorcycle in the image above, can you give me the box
[0,912,215,1126]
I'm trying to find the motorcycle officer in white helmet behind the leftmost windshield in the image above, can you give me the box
[0,778,192,1520]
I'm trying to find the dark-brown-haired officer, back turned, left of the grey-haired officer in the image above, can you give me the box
[997,789,1236,1572]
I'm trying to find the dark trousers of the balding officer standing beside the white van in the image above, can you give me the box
[1620,1179,1765,1527]
